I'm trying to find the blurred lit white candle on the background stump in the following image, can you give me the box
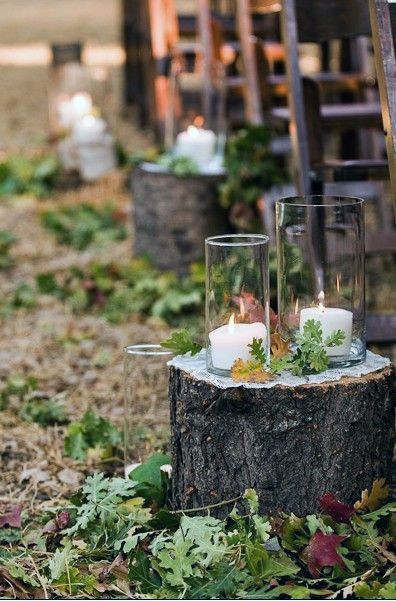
[174,125,216,167]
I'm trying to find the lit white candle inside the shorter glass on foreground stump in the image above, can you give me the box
[209,315,268,370]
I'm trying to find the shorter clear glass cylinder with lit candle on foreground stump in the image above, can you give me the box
[205,234,270,376]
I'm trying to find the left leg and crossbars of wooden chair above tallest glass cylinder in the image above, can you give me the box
[272,0,385,194]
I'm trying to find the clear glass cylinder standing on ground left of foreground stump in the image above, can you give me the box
[124,344,172,477]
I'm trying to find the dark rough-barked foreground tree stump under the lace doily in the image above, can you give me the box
[169,358,395,515]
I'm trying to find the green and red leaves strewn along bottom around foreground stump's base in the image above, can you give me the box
[0,453,396,599]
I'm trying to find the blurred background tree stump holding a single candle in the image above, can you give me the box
[131,167,230,273]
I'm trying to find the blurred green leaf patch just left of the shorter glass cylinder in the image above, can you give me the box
[36,259,204,323]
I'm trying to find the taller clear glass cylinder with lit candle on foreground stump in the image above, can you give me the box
[276,196,366,367]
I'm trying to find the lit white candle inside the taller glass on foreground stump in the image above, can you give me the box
[300,292,353,357]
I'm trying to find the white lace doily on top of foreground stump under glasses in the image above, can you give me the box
[168,350,390,388]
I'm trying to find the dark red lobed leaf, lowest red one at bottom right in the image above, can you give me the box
[301,530,347,578]
